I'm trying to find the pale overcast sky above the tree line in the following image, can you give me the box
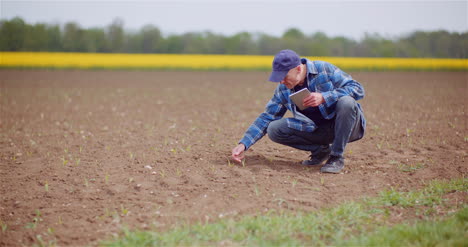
[0,0,468,39]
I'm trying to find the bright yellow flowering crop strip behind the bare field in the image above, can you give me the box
[0,52,468,70]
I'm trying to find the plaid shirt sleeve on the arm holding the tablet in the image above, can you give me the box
[322,64,364,107]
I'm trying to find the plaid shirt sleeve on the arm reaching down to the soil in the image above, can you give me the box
[239,86,287,150]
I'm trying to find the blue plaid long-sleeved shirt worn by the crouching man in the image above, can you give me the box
[239,58,366,150]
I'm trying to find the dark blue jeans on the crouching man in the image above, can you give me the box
[267,96,364,157]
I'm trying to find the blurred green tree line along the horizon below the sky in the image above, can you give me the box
[0,17,468,58]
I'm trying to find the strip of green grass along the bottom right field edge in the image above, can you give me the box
[101,178,468,246]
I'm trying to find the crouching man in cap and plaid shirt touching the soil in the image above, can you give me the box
[232,50,366,173]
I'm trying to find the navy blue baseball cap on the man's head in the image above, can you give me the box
[270,50,301,82]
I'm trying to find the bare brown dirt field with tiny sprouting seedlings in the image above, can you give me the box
[0,70,468,246]
